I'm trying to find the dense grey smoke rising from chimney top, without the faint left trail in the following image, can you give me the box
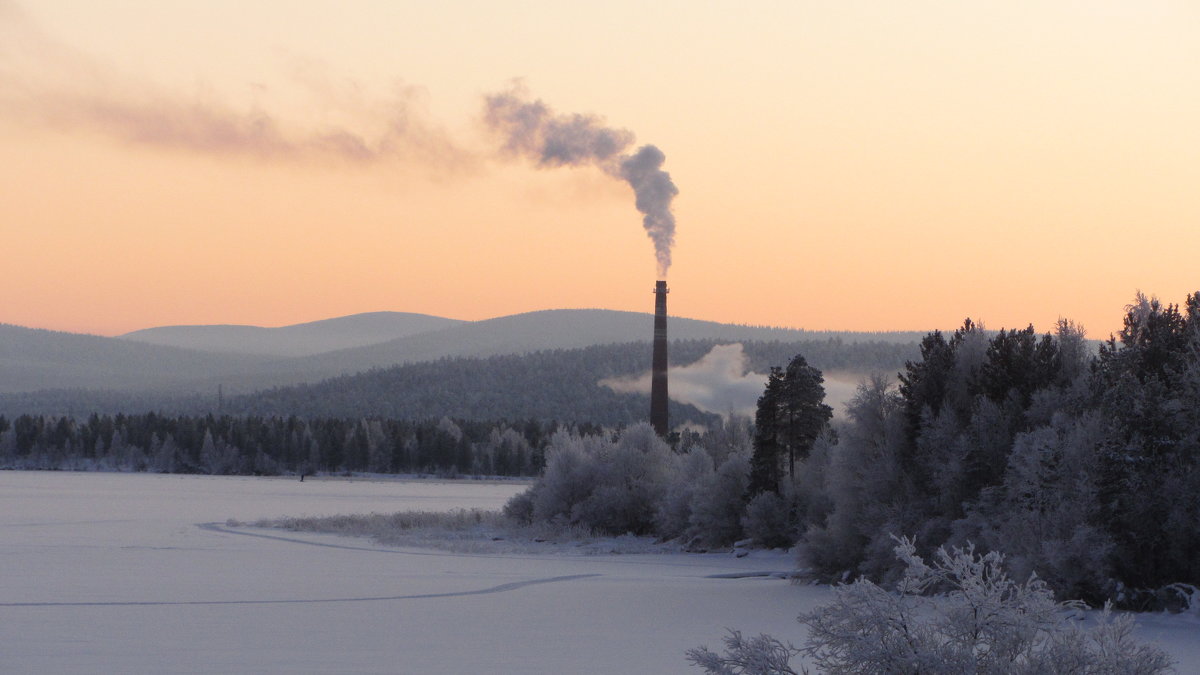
[485,88,679,277]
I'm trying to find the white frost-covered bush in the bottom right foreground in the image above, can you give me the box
[688,539,1170,675]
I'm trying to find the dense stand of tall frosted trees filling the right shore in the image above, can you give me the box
[793,294,1200,608]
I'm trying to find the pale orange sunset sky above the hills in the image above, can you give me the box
[0,0,1200,338]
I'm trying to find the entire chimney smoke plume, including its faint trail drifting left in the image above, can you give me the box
[0,6,679,267]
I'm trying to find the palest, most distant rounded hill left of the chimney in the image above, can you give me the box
[119,312,463,357]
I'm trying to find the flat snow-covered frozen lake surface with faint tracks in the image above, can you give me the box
[0,472,1200,674]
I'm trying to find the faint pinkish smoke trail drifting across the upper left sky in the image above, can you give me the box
[0,6,473,172]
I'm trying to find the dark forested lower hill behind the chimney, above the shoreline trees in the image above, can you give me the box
[0,339,918,426]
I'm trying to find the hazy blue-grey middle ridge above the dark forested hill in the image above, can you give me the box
[0,310,923,414]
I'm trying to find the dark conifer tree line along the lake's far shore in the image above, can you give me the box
[0,413,609,476]
